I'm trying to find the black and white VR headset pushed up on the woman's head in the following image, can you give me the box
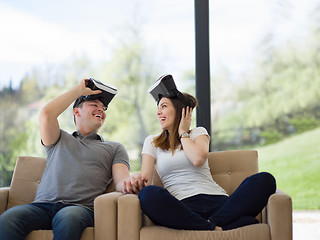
[148,74,188,106]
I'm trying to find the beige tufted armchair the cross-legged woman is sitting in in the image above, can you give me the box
[118,150,292,240]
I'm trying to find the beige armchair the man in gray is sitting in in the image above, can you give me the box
[0,157,122,240]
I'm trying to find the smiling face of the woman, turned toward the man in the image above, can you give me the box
[157,97,176,132]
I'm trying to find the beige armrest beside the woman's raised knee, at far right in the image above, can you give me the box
[266,189,292,240]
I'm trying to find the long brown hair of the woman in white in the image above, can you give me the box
[152,93,198,154]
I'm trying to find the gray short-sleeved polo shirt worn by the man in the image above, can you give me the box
[35,130,129,209]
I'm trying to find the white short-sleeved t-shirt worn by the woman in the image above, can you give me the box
[142,127,228,200]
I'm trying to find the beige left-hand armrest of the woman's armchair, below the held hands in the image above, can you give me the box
[118,194,142,240]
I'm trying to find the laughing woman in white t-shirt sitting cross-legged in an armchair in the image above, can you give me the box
[139,75,276,231]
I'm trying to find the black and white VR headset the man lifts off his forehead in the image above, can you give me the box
[73,78,118,110]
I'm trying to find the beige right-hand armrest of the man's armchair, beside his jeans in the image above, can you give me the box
[94,192,122,240]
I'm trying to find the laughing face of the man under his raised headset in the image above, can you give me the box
[75,100,106,131]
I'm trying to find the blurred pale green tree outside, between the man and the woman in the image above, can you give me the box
[98,24,159,163]
